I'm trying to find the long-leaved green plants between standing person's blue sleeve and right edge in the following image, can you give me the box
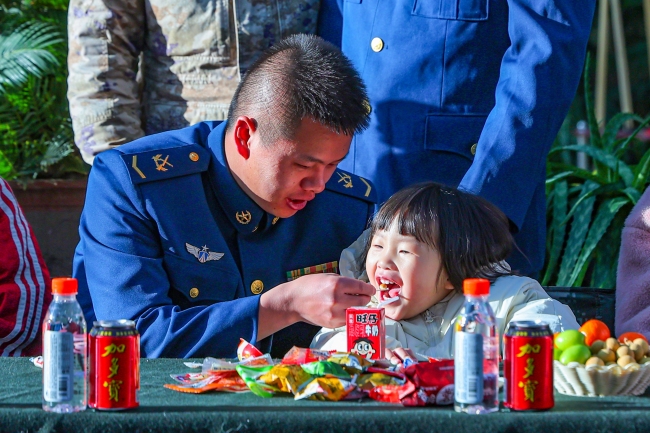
[540,0,650,289]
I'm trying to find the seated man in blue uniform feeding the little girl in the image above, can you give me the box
[73,35,376,357]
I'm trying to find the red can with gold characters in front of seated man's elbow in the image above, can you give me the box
[88,320,140,410]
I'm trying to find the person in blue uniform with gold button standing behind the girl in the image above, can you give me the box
[319,0,595,275]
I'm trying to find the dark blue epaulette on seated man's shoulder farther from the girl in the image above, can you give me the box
[121,144,210,185]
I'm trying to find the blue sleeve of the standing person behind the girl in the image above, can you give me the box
[459,0,595,228]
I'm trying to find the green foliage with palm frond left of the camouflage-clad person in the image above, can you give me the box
[0,0,88,180]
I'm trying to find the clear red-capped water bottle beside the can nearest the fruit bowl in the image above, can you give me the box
[454,278,499,414]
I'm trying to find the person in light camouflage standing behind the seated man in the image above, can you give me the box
[68,0,319,164]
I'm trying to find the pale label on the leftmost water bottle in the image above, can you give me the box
[43,331,74,403]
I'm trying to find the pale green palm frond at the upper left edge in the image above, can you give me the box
[0,22,63,94]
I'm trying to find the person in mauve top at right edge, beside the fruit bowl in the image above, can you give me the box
[616,188,650,339]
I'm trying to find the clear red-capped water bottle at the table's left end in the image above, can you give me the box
[43,278,88,413]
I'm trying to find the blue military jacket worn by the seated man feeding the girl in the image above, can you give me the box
[73,122,376,357]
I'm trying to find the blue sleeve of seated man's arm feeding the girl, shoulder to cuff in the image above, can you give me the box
[78,151,260,357]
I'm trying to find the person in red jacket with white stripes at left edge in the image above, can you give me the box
[0,178,52,356]
